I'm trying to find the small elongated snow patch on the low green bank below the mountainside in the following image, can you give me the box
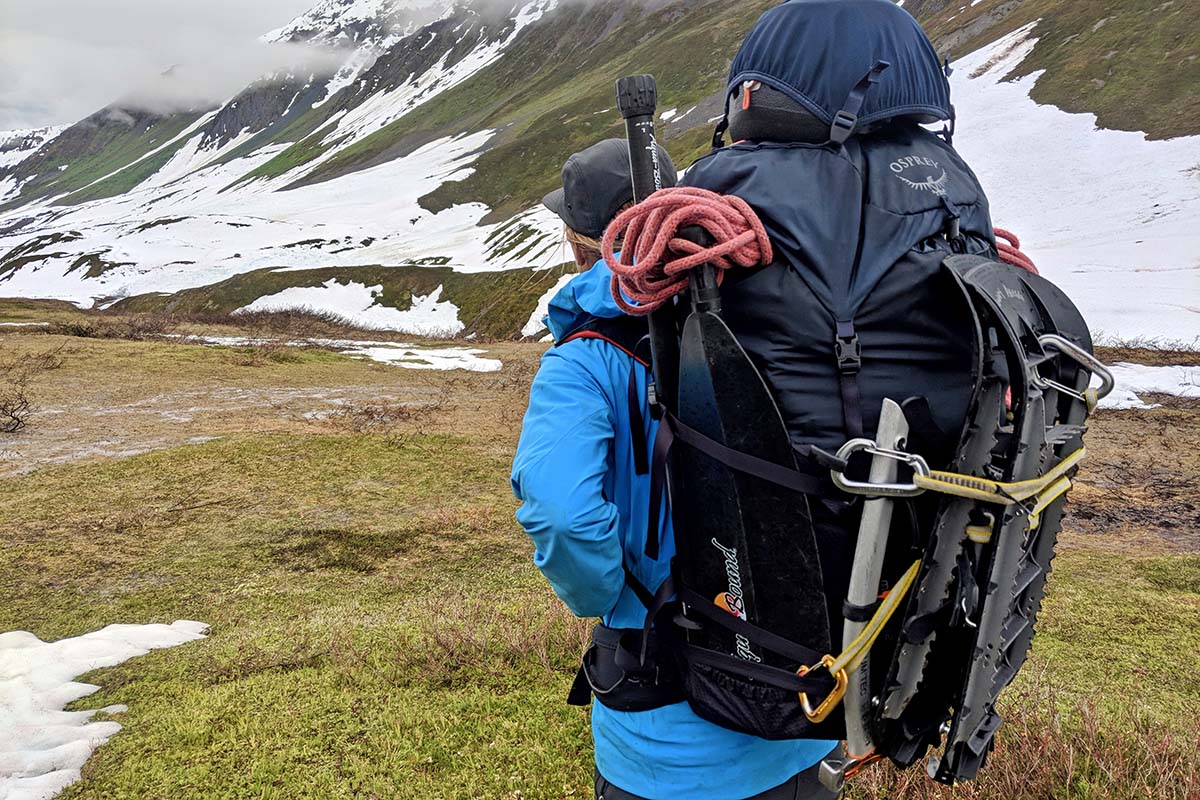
[234,278,466,336]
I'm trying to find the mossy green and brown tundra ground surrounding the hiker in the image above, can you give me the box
[0,303,1200,800]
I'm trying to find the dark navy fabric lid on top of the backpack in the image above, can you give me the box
[726,0,954,133]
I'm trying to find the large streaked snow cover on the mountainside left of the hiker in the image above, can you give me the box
[0,0,566,321]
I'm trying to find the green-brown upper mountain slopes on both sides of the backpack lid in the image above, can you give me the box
[274,0,1200,222]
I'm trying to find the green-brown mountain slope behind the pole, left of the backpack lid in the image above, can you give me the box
[295,0,774,222]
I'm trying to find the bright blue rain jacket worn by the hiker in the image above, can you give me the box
[512,261,836,800]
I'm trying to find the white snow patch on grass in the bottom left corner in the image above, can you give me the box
[0,620,209,800]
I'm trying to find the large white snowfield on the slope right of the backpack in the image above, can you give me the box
[950,23,1200,343]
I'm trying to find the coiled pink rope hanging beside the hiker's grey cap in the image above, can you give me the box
[600,187,774,317]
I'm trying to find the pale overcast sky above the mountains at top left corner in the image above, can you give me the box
[0,0,317,131]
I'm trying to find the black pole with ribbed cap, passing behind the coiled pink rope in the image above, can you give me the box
[617,76,679,408]
